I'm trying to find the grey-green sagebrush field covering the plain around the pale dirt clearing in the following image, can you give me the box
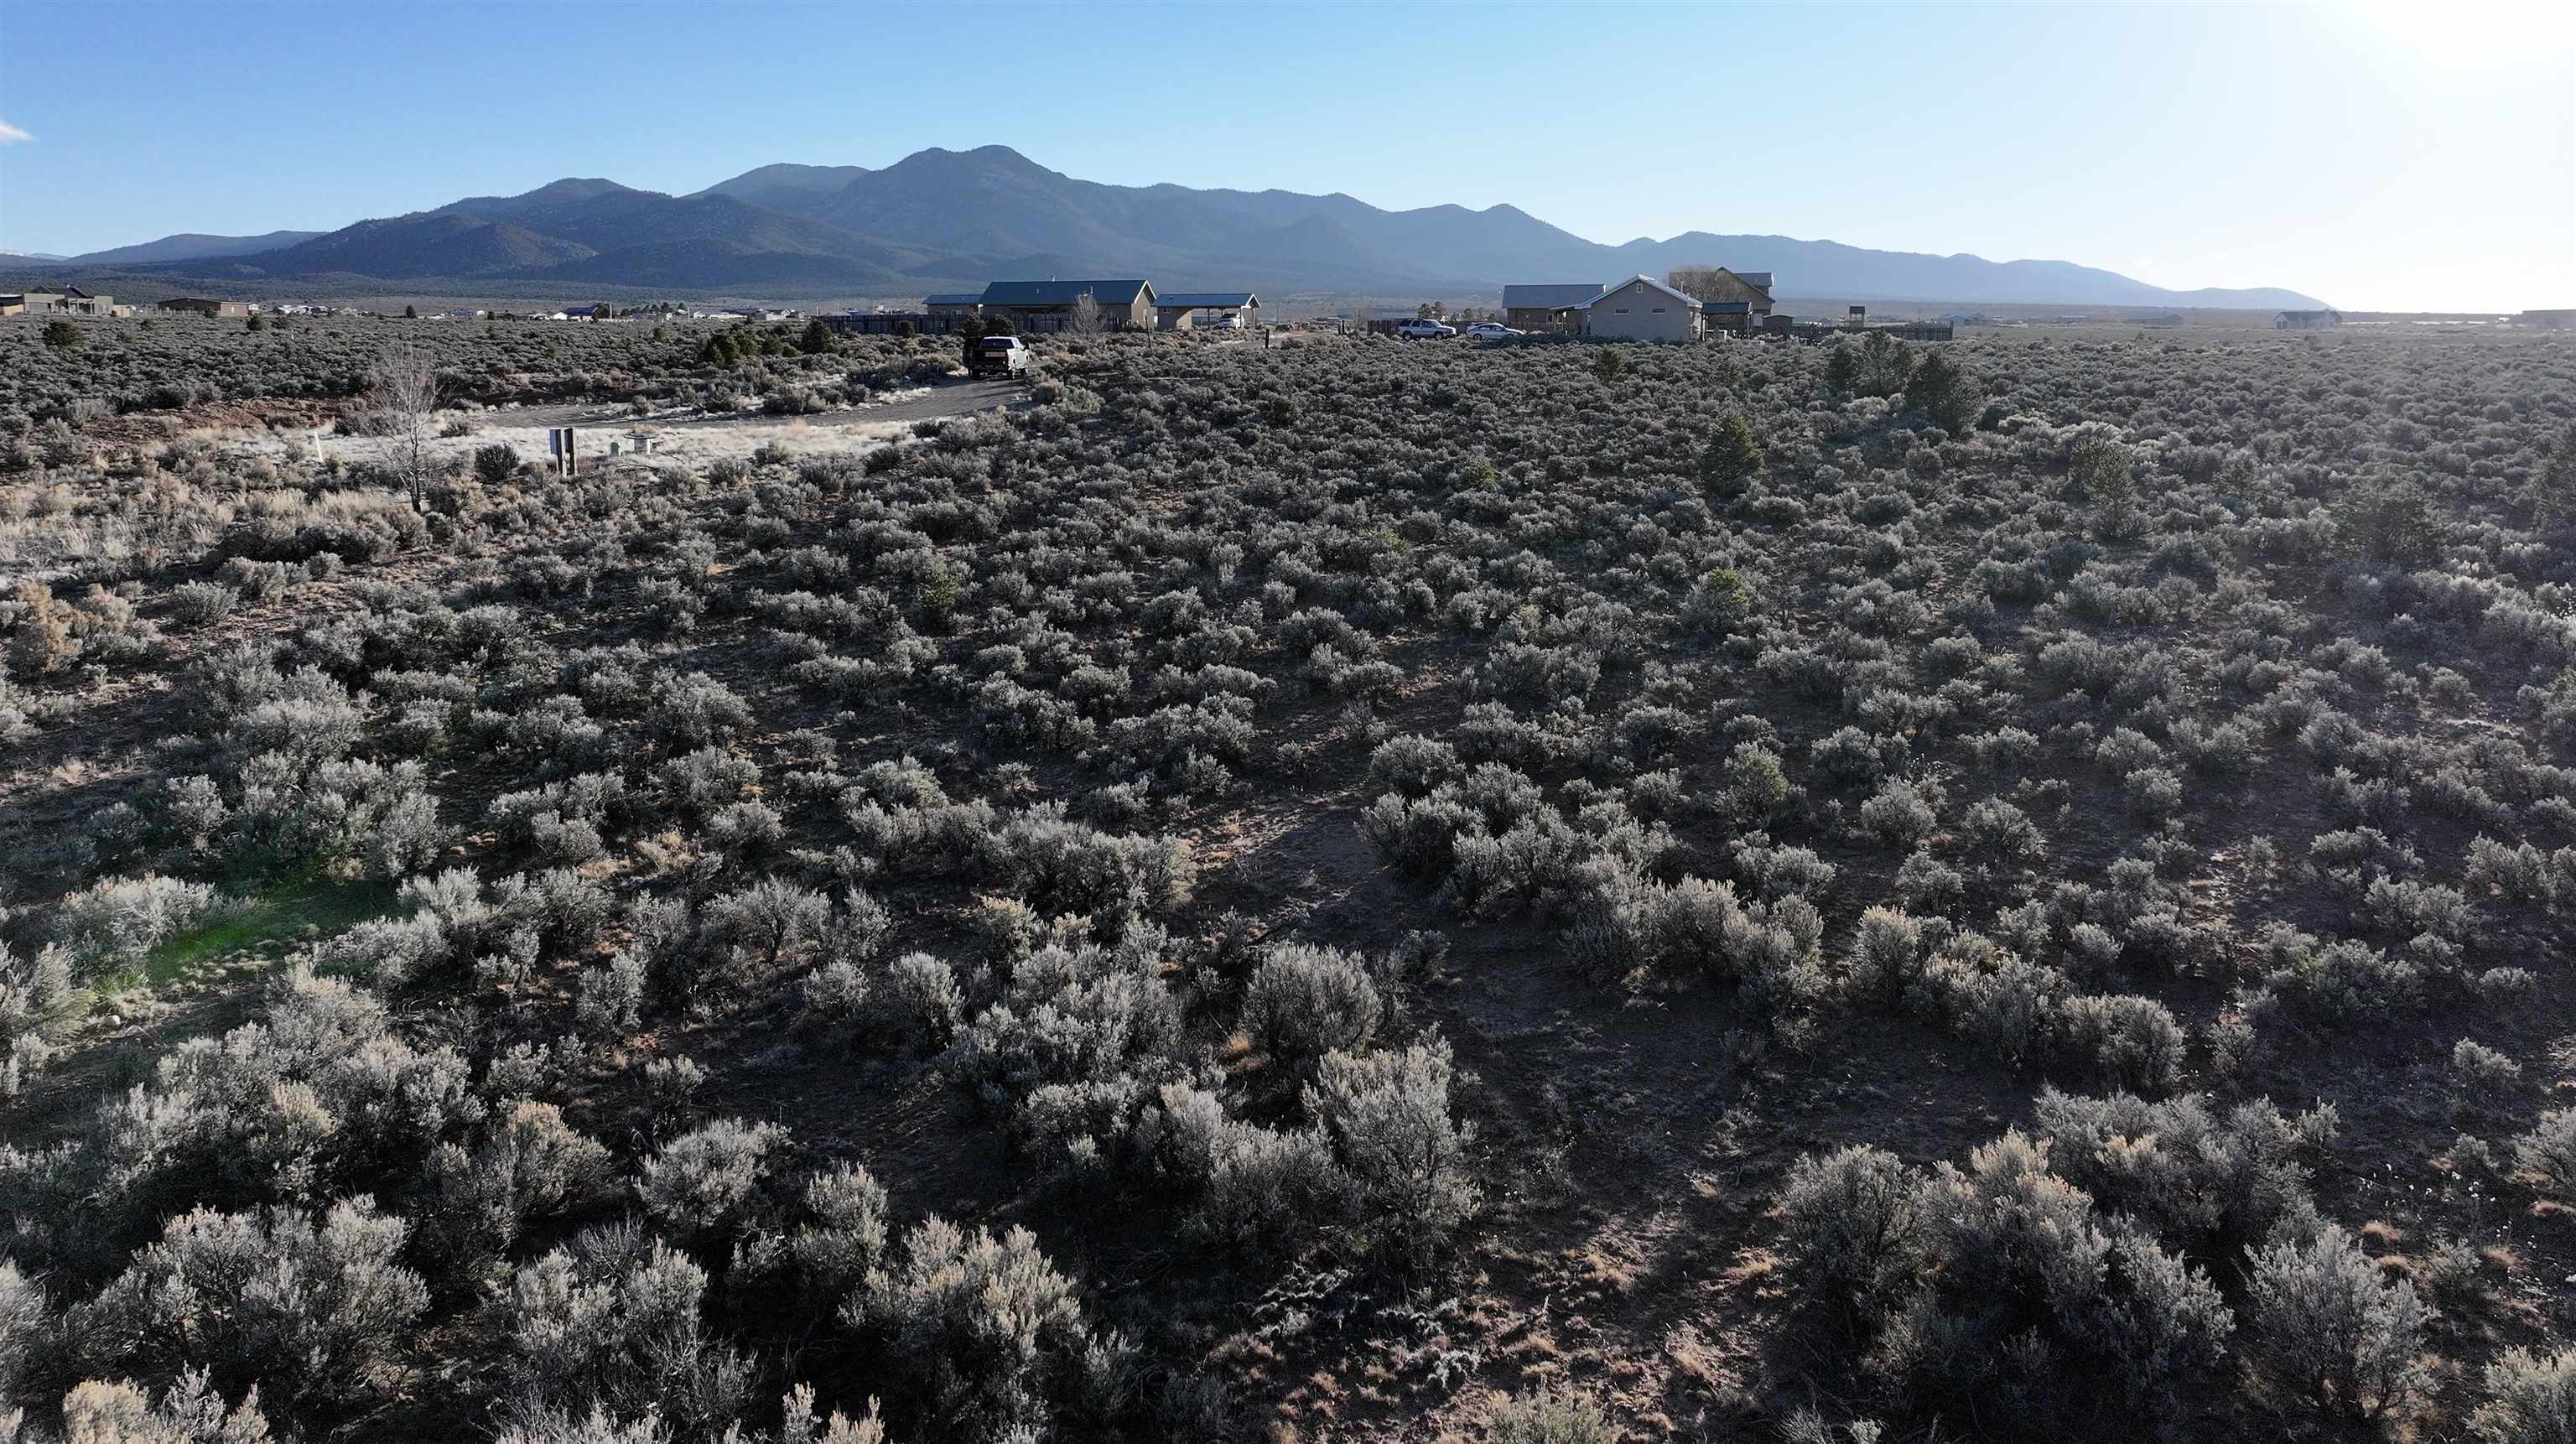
[0,325,2576,1444]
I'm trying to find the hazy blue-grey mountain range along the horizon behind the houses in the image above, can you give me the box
[0,147,2319,309]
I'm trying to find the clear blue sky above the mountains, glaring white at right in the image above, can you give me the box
[0,0,2576,309]
